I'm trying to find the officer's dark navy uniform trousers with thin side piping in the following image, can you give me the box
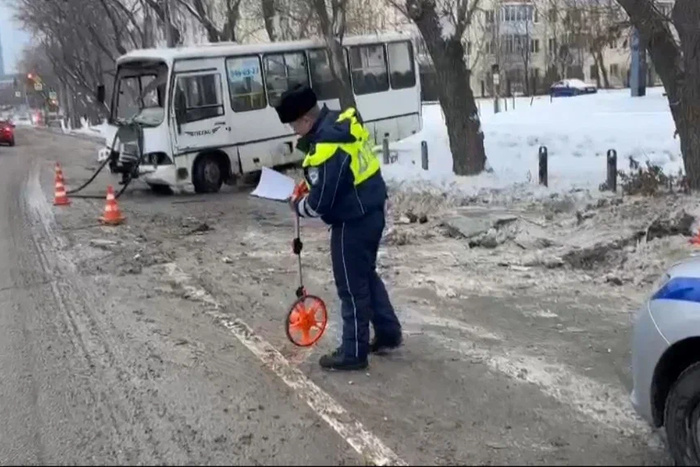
[331,209,401,360]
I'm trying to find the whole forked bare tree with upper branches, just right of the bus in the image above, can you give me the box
[392,0,486,175]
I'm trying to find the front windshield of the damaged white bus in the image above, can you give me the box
[112,64,168,126]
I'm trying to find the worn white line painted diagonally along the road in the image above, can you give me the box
[165,263,408,465]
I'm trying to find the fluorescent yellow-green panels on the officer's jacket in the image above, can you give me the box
[302,107,380,186]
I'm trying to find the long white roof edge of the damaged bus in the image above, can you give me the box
[117,32,414,65]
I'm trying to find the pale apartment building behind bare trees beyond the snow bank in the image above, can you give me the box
[465,0,673,96]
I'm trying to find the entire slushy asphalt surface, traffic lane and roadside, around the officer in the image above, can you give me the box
[0,129,667,465]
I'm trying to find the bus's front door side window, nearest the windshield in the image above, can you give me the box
[175,73,224,123]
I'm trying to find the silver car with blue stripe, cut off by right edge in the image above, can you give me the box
[630,256,700,465]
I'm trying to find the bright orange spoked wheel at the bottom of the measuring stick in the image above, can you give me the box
[286,295,328,347]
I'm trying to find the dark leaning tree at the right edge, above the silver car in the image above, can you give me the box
[617,0,700,190]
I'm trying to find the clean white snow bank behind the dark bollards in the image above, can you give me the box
[382,88,683,196]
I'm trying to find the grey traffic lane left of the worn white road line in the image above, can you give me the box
[0,129,361,465]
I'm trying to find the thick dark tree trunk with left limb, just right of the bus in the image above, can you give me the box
[406,0,486,175]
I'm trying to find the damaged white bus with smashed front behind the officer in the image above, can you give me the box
[98,33,422,193]
